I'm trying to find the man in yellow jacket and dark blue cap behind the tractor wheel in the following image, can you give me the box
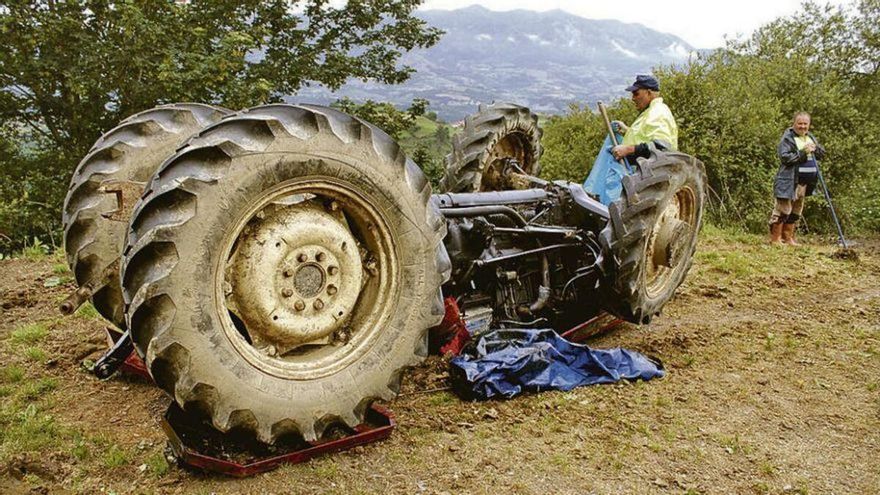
[611,75,678,164]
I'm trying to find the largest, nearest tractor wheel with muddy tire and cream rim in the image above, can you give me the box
[122,105,450,443]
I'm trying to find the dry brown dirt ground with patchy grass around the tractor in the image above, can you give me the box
[0,229,880,494]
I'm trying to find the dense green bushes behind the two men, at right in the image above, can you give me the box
[544,0,880,231]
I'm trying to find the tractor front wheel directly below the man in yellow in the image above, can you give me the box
[599,152,706,324]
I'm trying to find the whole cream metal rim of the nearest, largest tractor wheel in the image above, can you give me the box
[215,177,400,380]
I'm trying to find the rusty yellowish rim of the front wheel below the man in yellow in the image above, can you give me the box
[644,186,697,297]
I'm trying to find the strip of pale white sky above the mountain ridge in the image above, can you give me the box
[421,0,852,48]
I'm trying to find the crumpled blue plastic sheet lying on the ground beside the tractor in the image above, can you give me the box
[452,329,664,400]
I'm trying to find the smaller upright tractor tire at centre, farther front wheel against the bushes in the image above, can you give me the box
[440,103,542,193]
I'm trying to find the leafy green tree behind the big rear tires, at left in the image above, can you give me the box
[0,0,441,252]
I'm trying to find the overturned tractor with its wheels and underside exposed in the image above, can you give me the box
[64,104,705,443]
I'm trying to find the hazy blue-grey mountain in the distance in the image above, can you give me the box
[289,6,695,121]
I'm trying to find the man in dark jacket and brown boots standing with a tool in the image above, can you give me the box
[770,112,825,246]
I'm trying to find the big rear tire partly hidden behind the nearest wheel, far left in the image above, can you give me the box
[62,103,229,328]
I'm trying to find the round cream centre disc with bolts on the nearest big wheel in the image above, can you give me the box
[227,201,363,355]
